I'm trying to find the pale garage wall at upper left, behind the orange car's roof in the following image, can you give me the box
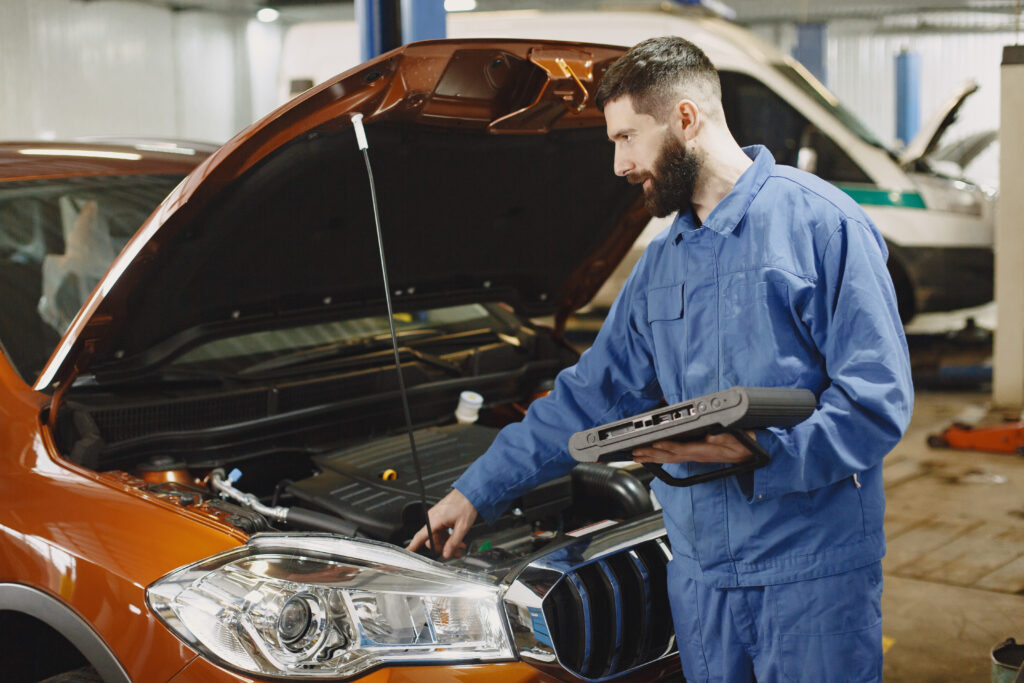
[0,0,281,142]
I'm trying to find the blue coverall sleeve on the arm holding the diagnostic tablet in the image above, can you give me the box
[751,218,913,503]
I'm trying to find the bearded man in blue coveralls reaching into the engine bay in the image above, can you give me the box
[410,37,913,683]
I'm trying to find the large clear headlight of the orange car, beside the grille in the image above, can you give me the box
[146,533,514,678]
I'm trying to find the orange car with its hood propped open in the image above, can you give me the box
[0,41,679,682]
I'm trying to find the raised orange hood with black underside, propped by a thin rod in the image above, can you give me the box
[36,40,648,389]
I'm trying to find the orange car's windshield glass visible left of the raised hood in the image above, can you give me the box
[0,174,182,380]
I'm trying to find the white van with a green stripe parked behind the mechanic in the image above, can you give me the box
[284,9,994,322]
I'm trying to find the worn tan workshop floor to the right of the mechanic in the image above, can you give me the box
[882,390,1024,682]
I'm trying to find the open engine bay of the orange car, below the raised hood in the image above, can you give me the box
[55,315,654,575]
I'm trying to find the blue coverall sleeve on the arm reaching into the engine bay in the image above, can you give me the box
[453,258,662,523]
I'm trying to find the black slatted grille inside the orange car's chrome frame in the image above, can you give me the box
[544,541,675,679]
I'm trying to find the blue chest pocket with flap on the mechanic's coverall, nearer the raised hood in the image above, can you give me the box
[647,283,686,402]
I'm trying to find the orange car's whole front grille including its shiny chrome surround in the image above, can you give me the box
[504,513,678,682]
